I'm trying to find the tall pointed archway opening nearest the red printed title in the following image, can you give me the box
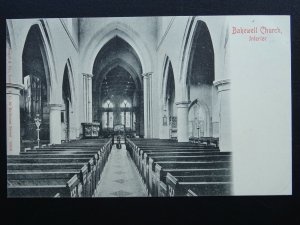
[186,21,216,137]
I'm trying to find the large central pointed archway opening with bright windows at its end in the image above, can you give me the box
[93,36,144,136]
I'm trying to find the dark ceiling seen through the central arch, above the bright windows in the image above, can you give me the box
[93,36,142,103]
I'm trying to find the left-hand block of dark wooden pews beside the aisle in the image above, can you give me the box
[8,138,111,197]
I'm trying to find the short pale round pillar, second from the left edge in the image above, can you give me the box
[49,104,62,144]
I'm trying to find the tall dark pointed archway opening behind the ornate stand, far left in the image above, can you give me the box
[20,24,50,143]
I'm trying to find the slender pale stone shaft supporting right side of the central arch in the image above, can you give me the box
[142,72,153,138]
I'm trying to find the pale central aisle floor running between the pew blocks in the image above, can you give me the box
[95,144,148,197]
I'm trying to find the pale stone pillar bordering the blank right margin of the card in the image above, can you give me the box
[214,79,232,151]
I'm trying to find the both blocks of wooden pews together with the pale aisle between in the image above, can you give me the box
[7,135,231,198]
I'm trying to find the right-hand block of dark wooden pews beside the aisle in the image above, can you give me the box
[126,140,231,196]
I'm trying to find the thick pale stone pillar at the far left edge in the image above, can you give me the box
[6,83,23,155]
